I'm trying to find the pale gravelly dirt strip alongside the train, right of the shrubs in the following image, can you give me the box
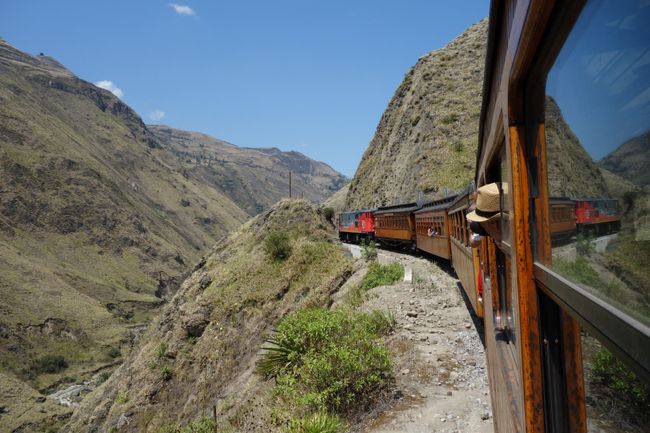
[340,245,493,433]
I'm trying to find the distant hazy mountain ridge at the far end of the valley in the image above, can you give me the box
[148,126,347,216]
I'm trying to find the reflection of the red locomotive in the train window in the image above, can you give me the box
[575,198,621,236]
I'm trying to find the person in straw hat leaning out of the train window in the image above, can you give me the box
[467,182,508,242]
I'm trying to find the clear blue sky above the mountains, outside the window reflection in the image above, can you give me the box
[0,0,488,176]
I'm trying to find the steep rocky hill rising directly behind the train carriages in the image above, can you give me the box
[346,19,487,208]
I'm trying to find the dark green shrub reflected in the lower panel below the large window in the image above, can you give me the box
[592,348,650,407]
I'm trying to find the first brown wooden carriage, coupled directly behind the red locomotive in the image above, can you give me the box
[374,203,420,248]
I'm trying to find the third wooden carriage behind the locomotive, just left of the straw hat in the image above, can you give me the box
[447,188,483,317]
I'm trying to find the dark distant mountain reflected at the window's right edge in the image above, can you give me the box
[599,130,650,187]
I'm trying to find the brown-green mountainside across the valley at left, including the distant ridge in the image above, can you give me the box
[0,40,345,418]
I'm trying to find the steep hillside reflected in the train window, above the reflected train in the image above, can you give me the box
[545,96,611,198]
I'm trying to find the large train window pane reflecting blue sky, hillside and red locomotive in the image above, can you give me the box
[545,0,650,324]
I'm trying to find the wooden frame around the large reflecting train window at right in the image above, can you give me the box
[525,2,650,383]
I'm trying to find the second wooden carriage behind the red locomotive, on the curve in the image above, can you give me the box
[414,196,456,260]
